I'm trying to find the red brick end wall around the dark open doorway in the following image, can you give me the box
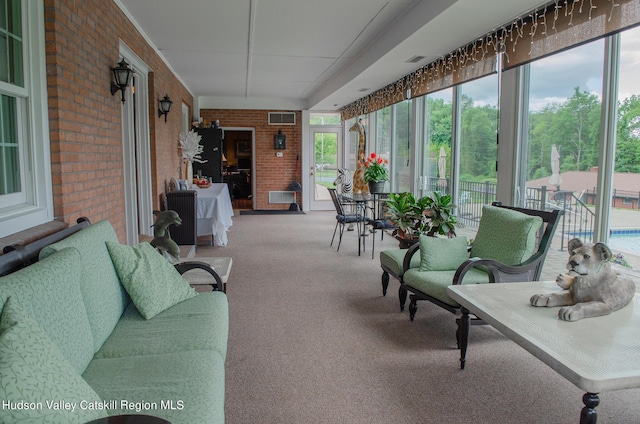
[200,109,302,209]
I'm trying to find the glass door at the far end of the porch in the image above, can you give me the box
[307,126,342,210]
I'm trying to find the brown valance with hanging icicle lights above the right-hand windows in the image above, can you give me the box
[340,0,640,121]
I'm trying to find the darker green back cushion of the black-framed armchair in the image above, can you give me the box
[471,205,542,265]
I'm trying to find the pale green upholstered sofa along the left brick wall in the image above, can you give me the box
[0,221,229,424]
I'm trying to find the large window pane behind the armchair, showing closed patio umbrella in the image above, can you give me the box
[526,40,604,247]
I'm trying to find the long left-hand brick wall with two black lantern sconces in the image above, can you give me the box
[44,0,193,240]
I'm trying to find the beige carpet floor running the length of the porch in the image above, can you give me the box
[196,212,640,424]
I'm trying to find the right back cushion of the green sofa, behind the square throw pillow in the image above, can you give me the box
[40,221,131,352]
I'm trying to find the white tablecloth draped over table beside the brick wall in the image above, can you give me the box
[193,183,233,246]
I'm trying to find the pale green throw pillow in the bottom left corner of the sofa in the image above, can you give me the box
[0,297,107,424]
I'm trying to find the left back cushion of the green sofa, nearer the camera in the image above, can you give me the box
[0,248,95,373]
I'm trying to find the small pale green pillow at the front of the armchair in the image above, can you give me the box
[419,235,469,271]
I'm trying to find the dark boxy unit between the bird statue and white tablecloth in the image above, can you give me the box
[167,190,198,246]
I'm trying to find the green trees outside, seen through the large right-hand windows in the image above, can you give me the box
[425,87,640,182]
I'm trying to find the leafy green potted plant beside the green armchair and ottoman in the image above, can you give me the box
[387,192,457,248]
